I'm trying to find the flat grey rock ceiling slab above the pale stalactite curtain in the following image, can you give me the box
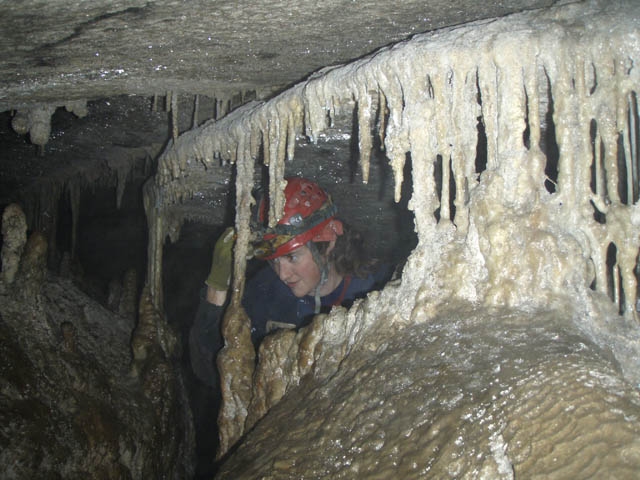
[0,0,555,110]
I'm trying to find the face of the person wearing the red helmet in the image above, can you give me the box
[269,245,320,298]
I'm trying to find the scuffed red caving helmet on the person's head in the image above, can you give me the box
[254,177,343,260]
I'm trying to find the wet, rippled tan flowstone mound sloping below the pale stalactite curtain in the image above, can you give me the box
[218,305,640,479]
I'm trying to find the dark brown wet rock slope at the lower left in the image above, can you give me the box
[0,258,194,479]
